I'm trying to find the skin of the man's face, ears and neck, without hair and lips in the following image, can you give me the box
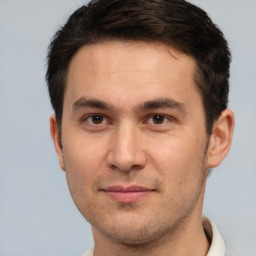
[50,41,234,256]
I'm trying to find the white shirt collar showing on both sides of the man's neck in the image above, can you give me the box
[82,218,225,256]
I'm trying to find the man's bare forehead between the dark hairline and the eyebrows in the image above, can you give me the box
[64,41,200,108]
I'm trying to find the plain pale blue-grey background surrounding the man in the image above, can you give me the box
[0,0,256,256]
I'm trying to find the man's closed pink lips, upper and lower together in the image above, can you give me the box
[101,185,155,203]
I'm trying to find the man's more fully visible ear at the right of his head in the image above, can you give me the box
[206,109,235,169]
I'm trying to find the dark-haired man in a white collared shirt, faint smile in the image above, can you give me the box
[46,0,234,256]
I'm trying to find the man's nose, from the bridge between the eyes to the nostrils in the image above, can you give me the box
[107,124,146,171]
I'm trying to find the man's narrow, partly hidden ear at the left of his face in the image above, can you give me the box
[50,115,65,171]
